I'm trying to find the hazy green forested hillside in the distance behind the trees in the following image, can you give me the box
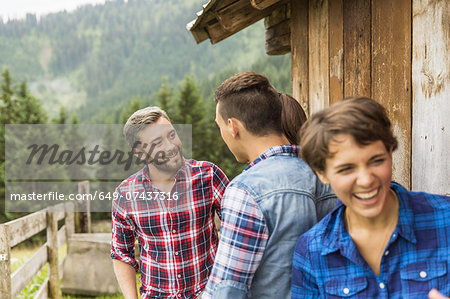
[0,0,272,122]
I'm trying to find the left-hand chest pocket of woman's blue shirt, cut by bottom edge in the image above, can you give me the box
[325,276,367,298]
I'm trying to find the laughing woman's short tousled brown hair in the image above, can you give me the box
[300,98,397,172]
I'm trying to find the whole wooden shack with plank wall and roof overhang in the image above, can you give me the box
[187,0,450,195]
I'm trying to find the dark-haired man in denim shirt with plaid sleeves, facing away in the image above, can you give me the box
[202,72,336,299]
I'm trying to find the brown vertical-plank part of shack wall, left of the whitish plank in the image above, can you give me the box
[291,0,411,188]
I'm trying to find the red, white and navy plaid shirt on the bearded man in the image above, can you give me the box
[111,160,228,299]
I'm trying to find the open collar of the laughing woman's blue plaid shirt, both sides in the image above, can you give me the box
[321,182,416,260]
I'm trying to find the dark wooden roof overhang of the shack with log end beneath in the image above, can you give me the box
[186,0,290,55]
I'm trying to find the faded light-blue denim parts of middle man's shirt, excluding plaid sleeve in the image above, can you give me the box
[206,146,336,299]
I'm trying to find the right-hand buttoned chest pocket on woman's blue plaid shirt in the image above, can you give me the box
[400,261,448,295]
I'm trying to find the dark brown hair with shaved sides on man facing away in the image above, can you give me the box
[214,72,282,136]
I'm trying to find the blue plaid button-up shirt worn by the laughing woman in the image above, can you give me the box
[292,183,450,299]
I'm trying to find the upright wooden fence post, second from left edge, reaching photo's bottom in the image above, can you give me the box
[47,209,61,299]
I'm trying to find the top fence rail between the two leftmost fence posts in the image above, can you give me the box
[6,210,47,247]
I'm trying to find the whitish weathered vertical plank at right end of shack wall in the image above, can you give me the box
[412,0,450,195]
